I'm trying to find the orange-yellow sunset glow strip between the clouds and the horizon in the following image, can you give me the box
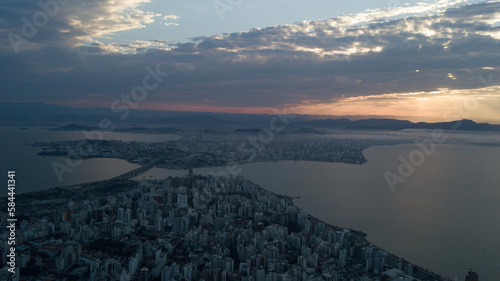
[47,86,500,124]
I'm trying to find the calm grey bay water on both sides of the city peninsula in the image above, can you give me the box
[0,128,500,281]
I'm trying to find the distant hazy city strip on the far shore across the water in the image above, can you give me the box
[35,133,382,169]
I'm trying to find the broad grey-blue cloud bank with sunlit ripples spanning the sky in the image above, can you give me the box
[0,0,500,116]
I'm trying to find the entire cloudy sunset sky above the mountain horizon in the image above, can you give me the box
[0,0,500,123]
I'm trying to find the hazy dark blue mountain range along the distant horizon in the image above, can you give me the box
[0,103,500,131]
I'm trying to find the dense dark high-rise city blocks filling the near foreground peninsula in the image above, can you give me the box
[0,175,454,281]
